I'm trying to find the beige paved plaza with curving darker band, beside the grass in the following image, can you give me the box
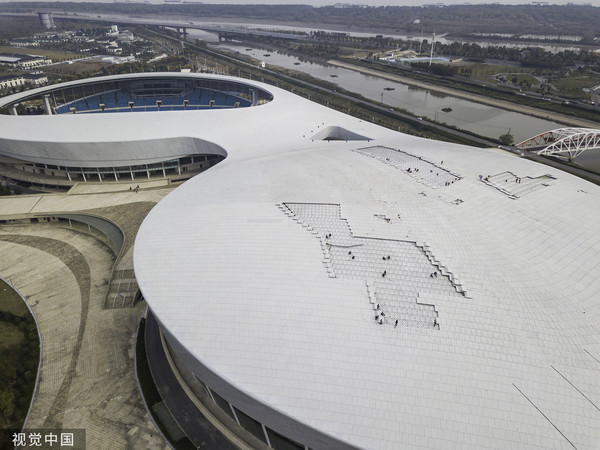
[0,223,168,450]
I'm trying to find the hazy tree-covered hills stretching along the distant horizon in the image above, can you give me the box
[0,1,600,35]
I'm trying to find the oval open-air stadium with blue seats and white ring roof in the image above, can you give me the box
[0,74,271,189]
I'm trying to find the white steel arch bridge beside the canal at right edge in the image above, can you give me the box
[516,128,600,161]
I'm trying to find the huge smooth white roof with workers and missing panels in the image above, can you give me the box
[132,75,600,449]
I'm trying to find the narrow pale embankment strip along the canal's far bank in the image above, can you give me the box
[327,60,599,128]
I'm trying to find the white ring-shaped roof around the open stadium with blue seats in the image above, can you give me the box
[0,73,272,167]
